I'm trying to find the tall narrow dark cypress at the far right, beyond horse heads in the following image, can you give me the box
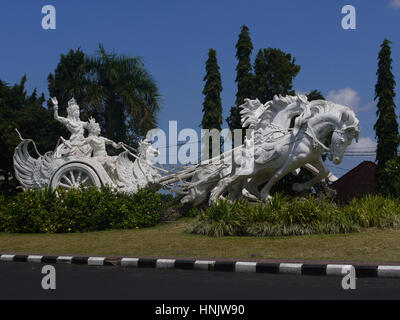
[374,39,400,181]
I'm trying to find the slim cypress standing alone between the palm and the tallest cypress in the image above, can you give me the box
[201,49,222,156]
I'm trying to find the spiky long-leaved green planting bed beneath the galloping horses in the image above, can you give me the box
[188,194,400,236]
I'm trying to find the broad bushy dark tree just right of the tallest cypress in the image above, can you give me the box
[254,48,300,103]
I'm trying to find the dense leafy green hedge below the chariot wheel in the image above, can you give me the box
[0,187,168,233]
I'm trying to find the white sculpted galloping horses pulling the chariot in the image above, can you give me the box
[182,95,360,205]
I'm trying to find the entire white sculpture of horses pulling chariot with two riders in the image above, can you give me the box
[14,95,360,206]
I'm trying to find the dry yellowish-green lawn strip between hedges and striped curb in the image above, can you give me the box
[0,219,400,263]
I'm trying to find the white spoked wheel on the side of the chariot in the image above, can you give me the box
[50,163,101,189]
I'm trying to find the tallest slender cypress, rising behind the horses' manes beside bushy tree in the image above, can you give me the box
[226,25,254,130]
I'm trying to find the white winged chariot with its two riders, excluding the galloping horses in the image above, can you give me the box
[13,98,160,193]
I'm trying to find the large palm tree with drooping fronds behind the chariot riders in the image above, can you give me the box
[87,45,160,144]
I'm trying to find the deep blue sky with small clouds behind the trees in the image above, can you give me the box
[0,0,400,176]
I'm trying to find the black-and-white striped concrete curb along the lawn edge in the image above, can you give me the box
[0,254,400,278]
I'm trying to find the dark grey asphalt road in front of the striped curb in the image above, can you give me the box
[0,262,400,300]
